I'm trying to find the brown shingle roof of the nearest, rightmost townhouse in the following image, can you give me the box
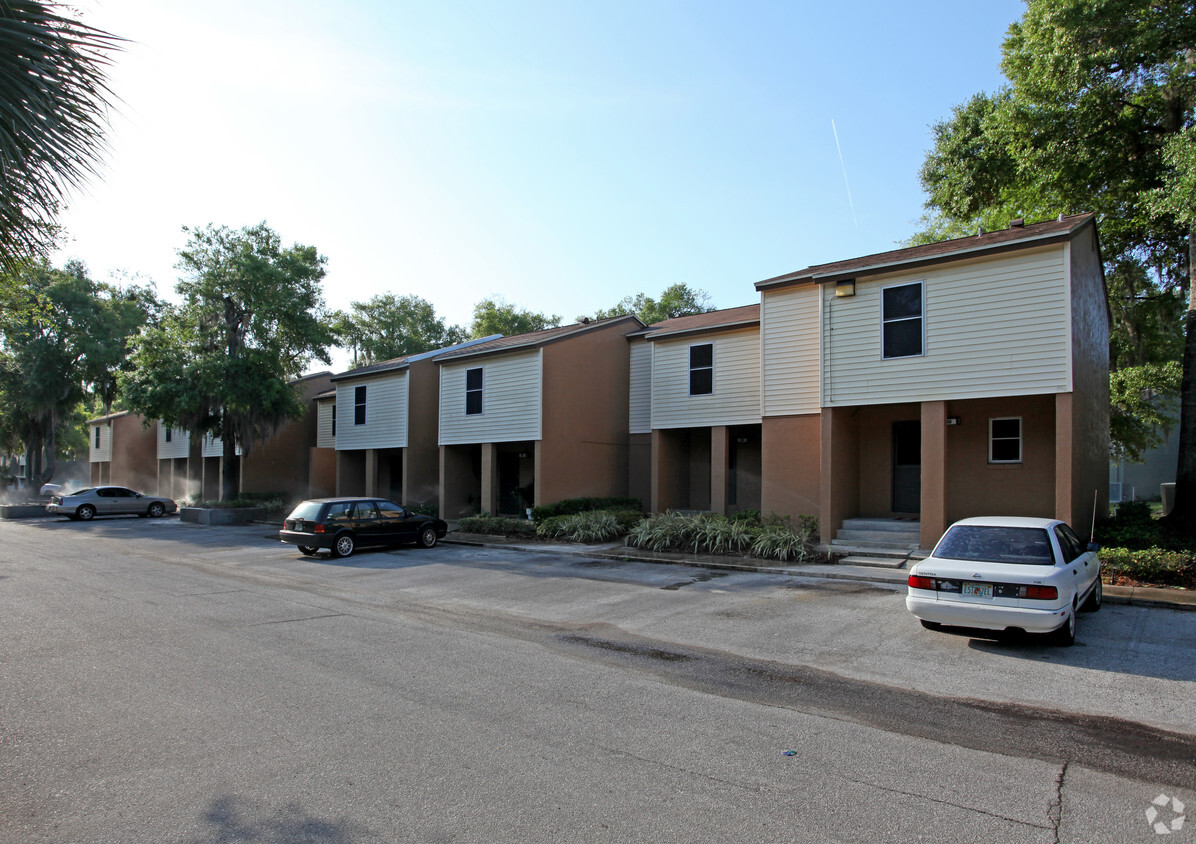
[756,214,1093,290]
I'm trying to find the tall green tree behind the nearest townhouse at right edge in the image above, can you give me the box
[915,0,1196,521]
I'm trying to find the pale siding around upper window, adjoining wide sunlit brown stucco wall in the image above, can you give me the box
[440,349,543,446]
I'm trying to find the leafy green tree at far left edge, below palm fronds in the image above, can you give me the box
[0,255,160,485]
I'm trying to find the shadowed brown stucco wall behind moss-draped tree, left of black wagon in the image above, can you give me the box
[240,373,332,499]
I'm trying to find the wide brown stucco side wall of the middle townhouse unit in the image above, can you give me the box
[536,320,640,504]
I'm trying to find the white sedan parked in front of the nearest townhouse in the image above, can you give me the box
[905,516,1103,646]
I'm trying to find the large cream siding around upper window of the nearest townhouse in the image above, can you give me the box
[822,246,1070,406]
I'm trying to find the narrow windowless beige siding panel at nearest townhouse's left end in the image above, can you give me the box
[761,285,820,416]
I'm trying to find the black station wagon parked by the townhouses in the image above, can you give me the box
[279,499,449,557]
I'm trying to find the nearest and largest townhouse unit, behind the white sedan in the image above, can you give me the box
[756,214,1109,548]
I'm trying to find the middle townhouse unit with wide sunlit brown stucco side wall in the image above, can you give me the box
[433,316,643,519]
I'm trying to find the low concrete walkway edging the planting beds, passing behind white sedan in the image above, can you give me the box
[444,531,1196,611]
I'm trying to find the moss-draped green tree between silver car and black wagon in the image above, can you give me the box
[122,222,334,499]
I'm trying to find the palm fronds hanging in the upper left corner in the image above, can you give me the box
[0,0,121,273]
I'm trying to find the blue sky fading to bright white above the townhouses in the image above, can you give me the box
[57,0,1024,365]
